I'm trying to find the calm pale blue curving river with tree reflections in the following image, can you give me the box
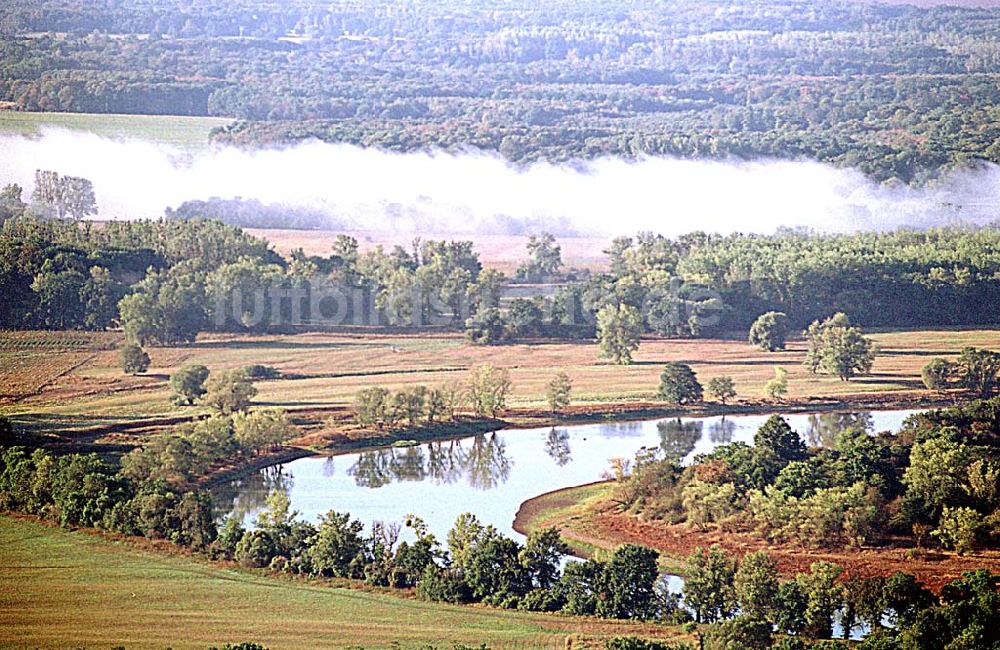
[213,411,916,543]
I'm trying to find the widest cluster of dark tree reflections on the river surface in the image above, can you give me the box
[347,429,512,490]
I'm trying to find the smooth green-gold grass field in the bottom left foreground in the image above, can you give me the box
[0,516,671,650]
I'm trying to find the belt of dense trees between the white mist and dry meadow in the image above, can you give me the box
[0,200,1000,336]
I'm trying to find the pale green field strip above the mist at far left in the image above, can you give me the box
[0,111,230,150]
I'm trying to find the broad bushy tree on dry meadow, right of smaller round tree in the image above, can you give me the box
[804,313,875,381]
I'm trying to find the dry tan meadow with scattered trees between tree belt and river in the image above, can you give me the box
[0,330,1000,443]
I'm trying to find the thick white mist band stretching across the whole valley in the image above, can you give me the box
[0,130,1000,235]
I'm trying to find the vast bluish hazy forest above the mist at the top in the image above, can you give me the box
[0,0,1000,182]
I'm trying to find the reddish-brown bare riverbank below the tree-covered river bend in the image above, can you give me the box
[514,481,1000,592]
